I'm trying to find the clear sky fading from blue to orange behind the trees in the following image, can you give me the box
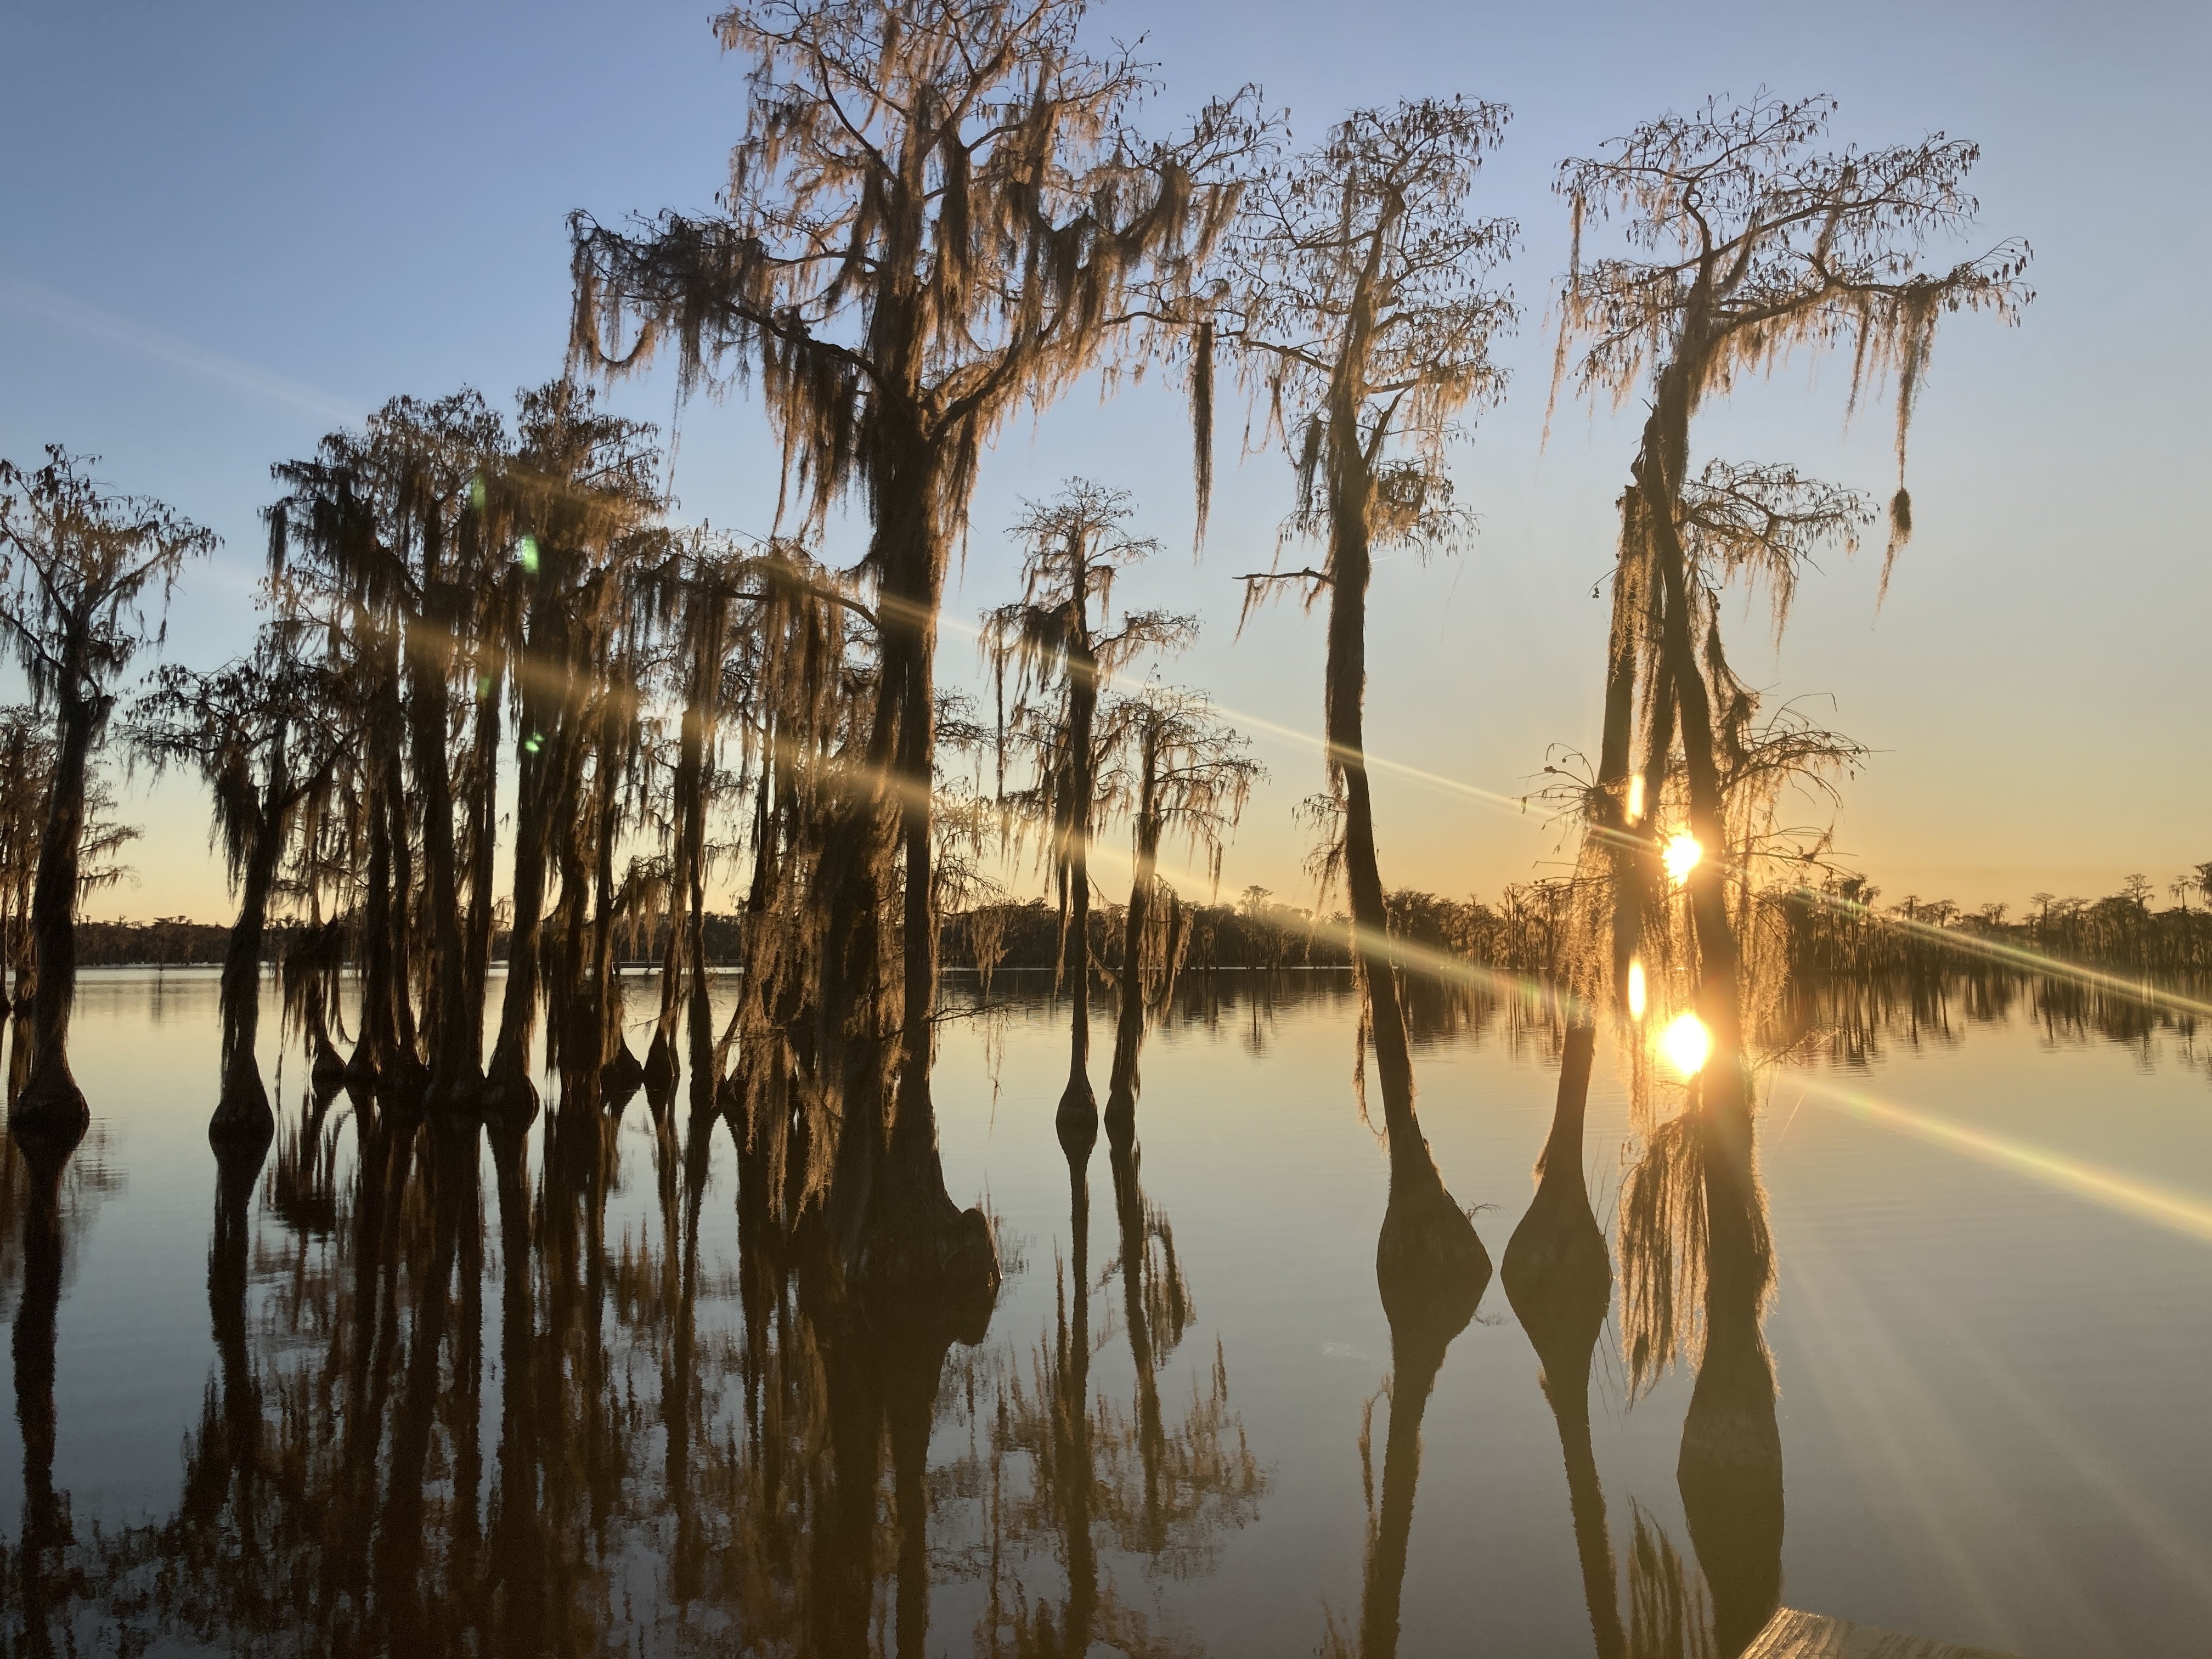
[0,0,2212,918]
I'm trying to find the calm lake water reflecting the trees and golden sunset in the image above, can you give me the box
[0,973,2212,1655]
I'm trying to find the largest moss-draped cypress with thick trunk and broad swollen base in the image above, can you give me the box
[573,0,1252,1300]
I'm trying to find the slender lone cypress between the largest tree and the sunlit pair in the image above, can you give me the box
[1223,97,1515,1288]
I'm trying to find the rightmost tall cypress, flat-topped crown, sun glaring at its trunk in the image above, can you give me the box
[1558,93,2026,1226]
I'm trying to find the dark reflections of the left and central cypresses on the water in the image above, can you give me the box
[4,1044,1265,1657]
